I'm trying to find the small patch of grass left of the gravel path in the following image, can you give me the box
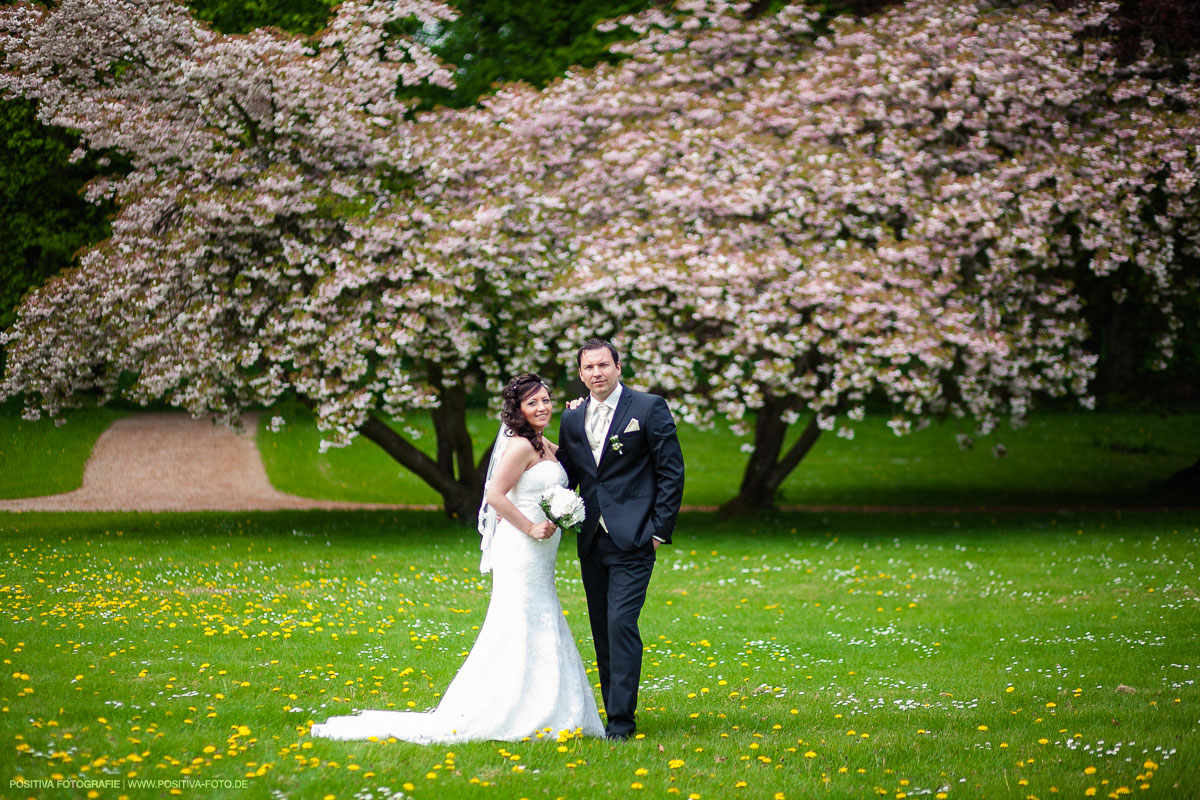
[0,408,125,499]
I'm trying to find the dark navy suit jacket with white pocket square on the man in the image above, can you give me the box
[558,385,683,557]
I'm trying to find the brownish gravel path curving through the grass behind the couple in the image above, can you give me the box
[0,413,406,511]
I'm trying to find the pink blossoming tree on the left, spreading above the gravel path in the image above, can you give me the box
[0,0,549,516]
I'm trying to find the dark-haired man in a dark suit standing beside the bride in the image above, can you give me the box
[558,339,683,739]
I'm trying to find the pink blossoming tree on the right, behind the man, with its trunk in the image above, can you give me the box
[480,0,1200,510]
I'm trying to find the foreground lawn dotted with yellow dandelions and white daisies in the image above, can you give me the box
[0,512,1200,800]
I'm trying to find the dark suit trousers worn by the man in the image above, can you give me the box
[580,527,655,736]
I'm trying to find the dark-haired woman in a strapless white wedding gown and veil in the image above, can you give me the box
[312,374,604,744]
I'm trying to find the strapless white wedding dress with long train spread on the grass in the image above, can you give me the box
[312,461,604,744]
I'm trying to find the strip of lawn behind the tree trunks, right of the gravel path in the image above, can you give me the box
[258,405,1200,507]
